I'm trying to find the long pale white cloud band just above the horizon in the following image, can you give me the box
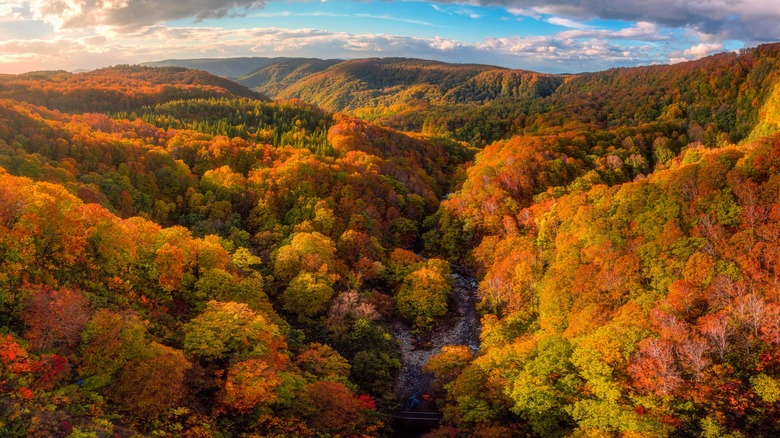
[0,25,685,72]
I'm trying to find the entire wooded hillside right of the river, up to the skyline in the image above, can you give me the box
[418,42,780,436]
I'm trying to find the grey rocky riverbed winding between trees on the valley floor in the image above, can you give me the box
[391,273,481,402]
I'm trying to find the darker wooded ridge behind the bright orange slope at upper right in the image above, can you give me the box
[366,44,780,146]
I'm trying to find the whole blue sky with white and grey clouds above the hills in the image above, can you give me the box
[0,0,780,73]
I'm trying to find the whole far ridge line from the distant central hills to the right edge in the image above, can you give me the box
[143,44,780,147]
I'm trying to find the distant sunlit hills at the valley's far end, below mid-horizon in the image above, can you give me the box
[144,58,567,111]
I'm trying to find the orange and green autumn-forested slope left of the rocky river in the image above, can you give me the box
[0,69,473,436]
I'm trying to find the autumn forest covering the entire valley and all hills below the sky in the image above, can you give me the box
[0,45,780,437]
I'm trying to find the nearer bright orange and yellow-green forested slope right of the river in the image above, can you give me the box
[429,135,780,436]
